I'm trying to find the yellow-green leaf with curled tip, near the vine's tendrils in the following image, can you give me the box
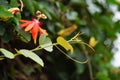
[57,37,73,53]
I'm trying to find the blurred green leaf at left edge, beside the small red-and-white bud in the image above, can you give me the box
[0,6,13,20]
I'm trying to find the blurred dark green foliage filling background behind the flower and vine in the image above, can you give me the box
[0,0,120,80]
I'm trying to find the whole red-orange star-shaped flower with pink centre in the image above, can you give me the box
[20,18,48,44]
